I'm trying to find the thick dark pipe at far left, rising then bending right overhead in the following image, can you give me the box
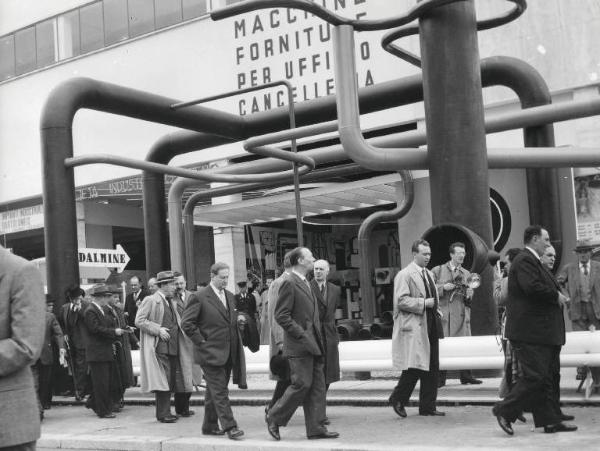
[40,78,244,306]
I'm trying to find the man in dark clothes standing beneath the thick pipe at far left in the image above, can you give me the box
[58,286,89,401]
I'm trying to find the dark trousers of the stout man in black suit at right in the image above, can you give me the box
[493,340,560,427]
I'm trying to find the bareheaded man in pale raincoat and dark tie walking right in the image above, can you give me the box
[389,239,445,418]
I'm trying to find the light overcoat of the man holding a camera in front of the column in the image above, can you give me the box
[431,262,471,337]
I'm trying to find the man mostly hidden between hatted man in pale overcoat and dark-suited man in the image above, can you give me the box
[173,271,196,417]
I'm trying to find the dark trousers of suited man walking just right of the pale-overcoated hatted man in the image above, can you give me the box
[202,361,237,431]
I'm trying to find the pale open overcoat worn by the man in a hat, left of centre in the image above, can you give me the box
[135,291,193,392]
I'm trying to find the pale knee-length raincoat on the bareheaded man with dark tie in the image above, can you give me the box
[392,262,437,371]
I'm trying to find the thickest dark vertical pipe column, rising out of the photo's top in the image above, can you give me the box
[419,0,497,335]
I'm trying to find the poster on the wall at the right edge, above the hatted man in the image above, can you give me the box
[573,168,600,245]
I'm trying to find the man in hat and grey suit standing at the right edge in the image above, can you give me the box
[556,242,600,388]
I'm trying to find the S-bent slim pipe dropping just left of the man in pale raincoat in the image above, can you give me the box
[357,171,415,324]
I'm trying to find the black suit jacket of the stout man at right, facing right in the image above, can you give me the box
[505,249,565,346]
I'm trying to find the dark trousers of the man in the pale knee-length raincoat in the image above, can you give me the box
[390,334,440,413]
